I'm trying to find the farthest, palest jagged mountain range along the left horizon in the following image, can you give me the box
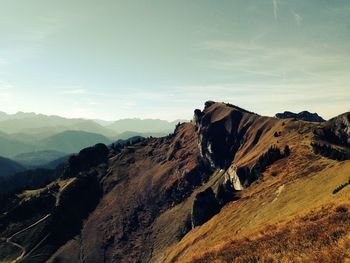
[0,112,186,136]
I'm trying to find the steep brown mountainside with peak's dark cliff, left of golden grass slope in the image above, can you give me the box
[47,102,290,262]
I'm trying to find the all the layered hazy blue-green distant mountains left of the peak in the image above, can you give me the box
[0,112,182,167]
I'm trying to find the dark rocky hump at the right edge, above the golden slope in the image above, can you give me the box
[315,112,350,147]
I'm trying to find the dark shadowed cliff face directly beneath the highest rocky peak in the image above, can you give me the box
[193,102,253,169]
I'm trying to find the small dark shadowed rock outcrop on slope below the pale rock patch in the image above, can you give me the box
[191,187,220,227]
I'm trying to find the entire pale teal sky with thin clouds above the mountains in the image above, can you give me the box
[0,0,350,120]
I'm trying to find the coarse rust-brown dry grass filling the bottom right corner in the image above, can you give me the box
[189,204,350,263]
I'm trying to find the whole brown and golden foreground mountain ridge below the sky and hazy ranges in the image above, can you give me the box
[0,101,350,263]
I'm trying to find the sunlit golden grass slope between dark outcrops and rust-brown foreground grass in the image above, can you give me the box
[166,112,350,262]
